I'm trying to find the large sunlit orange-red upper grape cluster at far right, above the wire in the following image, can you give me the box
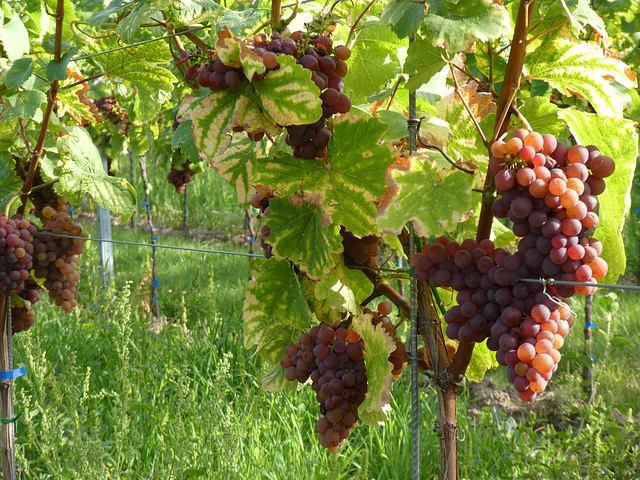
[490,130,615,298]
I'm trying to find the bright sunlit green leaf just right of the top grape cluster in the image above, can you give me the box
[344,21,406,105]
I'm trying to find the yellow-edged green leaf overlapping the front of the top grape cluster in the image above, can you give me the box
[252,55,322,126]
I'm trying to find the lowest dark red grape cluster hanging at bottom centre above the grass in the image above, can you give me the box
[280,324,367,453]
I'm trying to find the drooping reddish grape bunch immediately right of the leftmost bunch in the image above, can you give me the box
[33,207,86,313]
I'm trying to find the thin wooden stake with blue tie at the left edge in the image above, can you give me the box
[0,294,16,480]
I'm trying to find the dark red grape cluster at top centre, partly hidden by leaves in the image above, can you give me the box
[184,31,351,159]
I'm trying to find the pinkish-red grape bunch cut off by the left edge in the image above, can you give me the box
[0,213,37,297]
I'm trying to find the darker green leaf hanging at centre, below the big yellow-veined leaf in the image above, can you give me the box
[267,197,342,280]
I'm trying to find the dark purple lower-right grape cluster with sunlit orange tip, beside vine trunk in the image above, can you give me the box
[411,236,573,401]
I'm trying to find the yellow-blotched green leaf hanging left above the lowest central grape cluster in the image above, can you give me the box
[242,258,313,391]
